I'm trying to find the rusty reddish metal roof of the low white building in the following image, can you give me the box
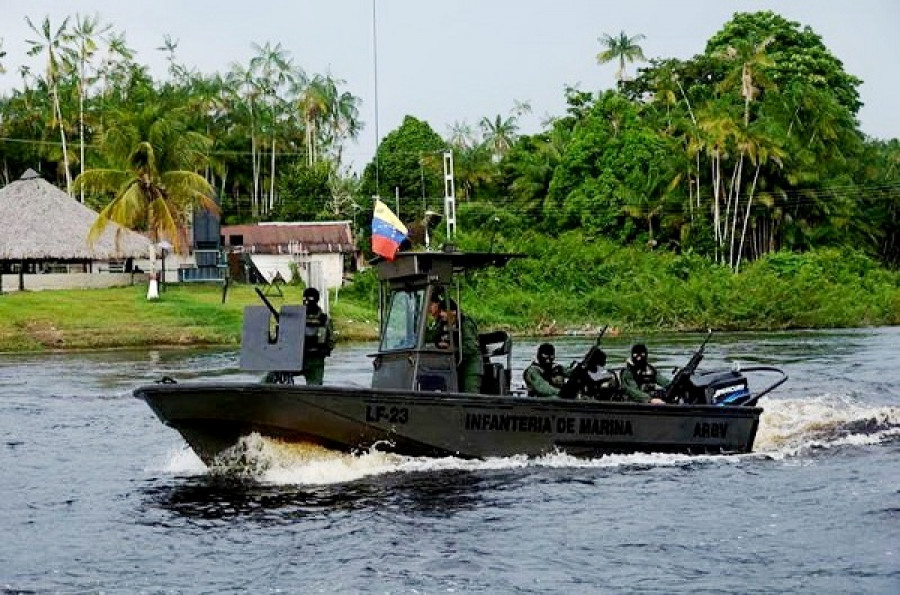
[221,221,356,254]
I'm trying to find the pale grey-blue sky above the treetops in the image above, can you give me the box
[0,0,900,169]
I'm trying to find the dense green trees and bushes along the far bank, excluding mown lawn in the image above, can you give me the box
[0,12,900,350]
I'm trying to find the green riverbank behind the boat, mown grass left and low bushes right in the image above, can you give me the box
[0,233,900,352]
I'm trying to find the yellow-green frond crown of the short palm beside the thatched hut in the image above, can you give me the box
[75,103,218,251]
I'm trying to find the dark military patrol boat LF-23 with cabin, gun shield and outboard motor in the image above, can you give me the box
[134,251,787,465]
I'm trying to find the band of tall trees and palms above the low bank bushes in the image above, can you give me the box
[0,11,900,271]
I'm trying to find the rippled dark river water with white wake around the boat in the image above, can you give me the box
[0,328,900,594]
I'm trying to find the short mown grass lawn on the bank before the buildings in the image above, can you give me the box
[0,285,378,352]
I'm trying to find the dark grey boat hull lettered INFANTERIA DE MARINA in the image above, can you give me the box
[134,384,762,464]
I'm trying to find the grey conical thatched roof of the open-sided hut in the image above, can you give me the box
[0,169,153,260]
